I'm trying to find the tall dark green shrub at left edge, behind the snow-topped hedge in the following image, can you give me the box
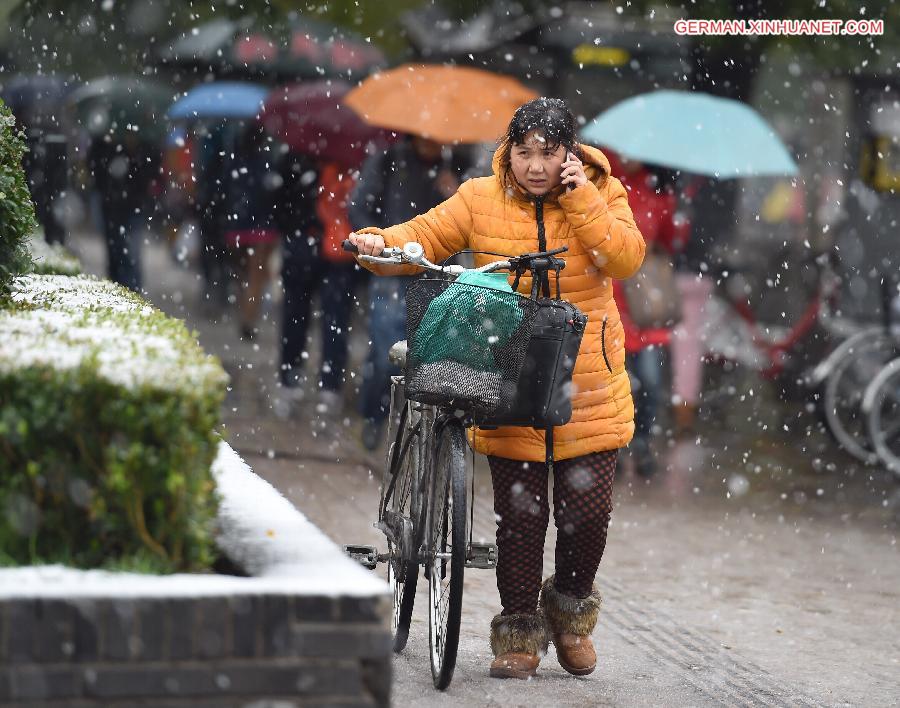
[0,101,37,300]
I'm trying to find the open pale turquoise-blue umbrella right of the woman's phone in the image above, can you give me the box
[582,91,797,178]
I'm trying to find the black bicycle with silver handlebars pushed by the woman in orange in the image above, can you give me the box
[344,236,568,690]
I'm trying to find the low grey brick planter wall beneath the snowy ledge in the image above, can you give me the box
[0,592,391,708]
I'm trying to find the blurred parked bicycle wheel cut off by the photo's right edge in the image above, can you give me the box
[823,332,897,464]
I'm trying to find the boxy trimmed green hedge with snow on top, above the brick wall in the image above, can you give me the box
[0,275,227,572]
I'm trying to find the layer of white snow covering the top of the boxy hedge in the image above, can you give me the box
[0,275,226,390]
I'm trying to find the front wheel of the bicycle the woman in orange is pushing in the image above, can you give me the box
[427,418,467,691]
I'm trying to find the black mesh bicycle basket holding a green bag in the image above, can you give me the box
[406,279,537,415]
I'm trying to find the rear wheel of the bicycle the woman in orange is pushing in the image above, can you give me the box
[380,404,421,652]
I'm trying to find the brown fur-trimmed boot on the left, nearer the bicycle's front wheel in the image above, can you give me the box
[491,613,548,679]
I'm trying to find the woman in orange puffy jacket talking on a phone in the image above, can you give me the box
[350,98,644,678]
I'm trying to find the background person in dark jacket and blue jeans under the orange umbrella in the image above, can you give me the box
[349,136,465,450]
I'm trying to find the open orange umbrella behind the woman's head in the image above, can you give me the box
[344,64,537,143]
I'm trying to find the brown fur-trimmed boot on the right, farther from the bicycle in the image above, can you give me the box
[540,575,600,676]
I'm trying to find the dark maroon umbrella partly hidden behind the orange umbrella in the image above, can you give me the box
[260,80,391,167]
